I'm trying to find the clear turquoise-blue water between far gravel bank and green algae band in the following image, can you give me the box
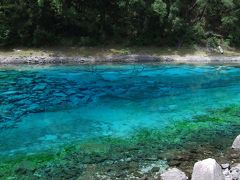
[0,64,240,156]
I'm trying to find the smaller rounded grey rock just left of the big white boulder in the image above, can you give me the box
[161,168,188,180]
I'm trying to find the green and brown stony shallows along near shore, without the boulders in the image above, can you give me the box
[0,105,240,179]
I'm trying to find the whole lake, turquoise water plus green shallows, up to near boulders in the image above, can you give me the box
[0,64,240,179]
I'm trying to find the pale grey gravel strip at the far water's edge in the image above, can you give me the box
[0,54,240,65]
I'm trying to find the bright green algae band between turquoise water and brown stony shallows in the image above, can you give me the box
[0,105,240,178]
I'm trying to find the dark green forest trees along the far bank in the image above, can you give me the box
[0,0,240,47]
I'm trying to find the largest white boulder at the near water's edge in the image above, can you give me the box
[192,158,224,180]
